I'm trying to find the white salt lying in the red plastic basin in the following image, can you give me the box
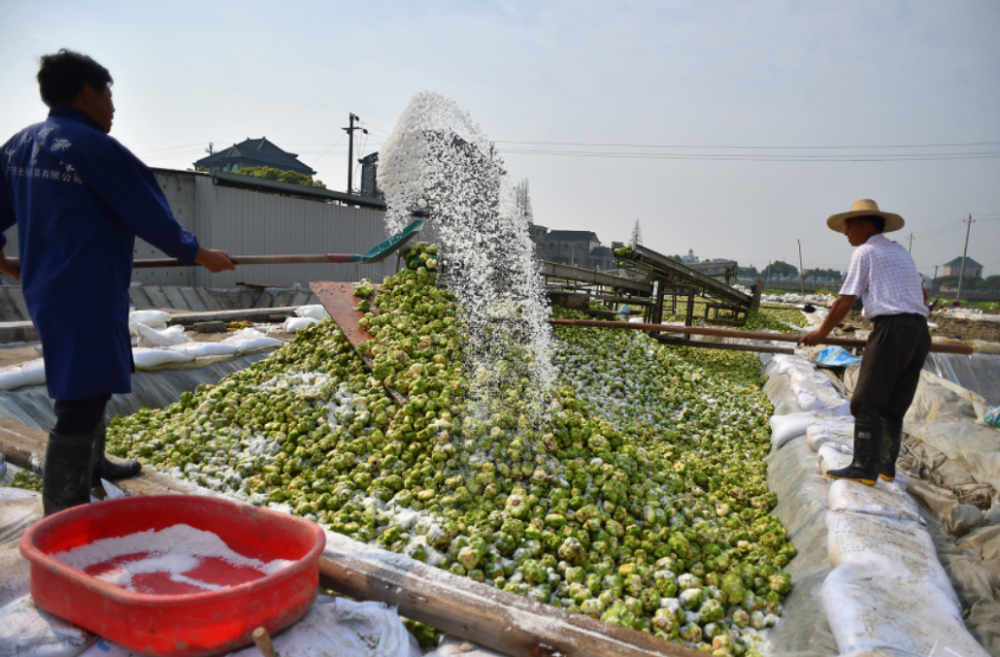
[53,525,294,593]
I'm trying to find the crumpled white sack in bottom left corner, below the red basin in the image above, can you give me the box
[0,595,97,657]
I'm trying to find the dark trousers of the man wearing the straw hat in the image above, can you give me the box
[851,315,931,422]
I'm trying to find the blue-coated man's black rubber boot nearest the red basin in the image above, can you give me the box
[42,433,94,516]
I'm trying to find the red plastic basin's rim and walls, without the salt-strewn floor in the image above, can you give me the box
[20,495,326,657]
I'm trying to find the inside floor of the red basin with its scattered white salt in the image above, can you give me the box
[52,524,294,595]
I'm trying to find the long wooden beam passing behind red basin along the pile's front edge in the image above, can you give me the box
[0,418,703,657]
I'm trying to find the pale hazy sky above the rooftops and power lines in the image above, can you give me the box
[0,0,1000,275]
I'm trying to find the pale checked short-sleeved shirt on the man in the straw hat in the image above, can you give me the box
[840,234,928,319]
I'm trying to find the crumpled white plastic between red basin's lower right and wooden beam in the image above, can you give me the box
[76,595,422,657]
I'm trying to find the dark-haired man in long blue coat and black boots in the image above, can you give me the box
[0,50,235,515]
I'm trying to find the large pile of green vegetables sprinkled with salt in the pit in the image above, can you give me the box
[108,245,795,656]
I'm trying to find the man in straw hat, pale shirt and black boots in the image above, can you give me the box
[799,199,931,486]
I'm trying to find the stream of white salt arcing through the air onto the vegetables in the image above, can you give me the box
[379,93,556,460]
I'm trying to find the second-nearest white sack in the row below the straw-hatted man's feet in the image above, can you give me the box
[826,511,961,609]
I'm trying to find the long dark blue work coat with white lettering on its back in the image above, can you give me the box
[0,106,199,400]
